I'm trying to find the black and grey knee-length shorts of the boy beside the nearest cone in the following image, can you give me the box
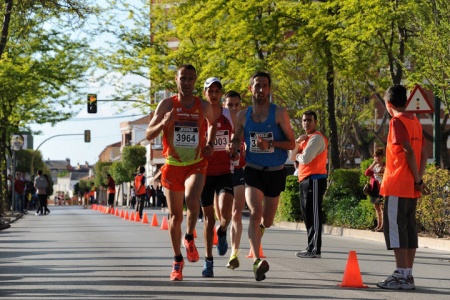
[383,196,419,250]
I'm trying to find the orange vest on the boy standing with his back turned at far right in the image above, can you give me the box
[380,114,423,198]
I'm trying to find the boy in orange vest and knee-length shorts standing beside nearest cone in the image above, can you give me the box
[377,85,429,290]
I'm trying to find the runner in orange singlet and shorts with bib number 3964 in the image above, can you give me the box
[146,65,216,280]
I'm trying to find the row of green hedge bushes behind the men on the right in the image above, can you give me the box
[275,164,450,237]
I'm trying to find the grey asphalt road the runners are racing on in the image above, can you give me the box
[0,206,450,300]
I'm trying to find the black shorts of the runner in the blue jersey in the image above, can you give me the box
[244,166,287,197]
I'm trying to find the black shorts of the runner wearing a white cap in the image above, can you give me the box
[201,173,234,207]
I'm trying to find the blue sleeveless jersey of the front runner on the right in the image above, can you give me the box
[244,103,288,167]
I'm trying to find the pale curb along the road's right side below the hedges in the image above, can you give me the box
[273,221,450,252]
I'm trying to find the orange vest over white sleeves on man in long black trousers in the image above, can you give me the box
[298,131,328,182]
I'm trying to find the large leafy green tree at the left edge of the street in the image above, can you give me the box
[0,0,98,212]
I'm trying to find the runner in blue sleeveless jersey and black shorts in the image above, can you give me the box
[230,72,295,281]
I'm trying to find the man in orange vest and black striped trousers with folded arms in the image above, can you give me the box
[290,110,328,258]
